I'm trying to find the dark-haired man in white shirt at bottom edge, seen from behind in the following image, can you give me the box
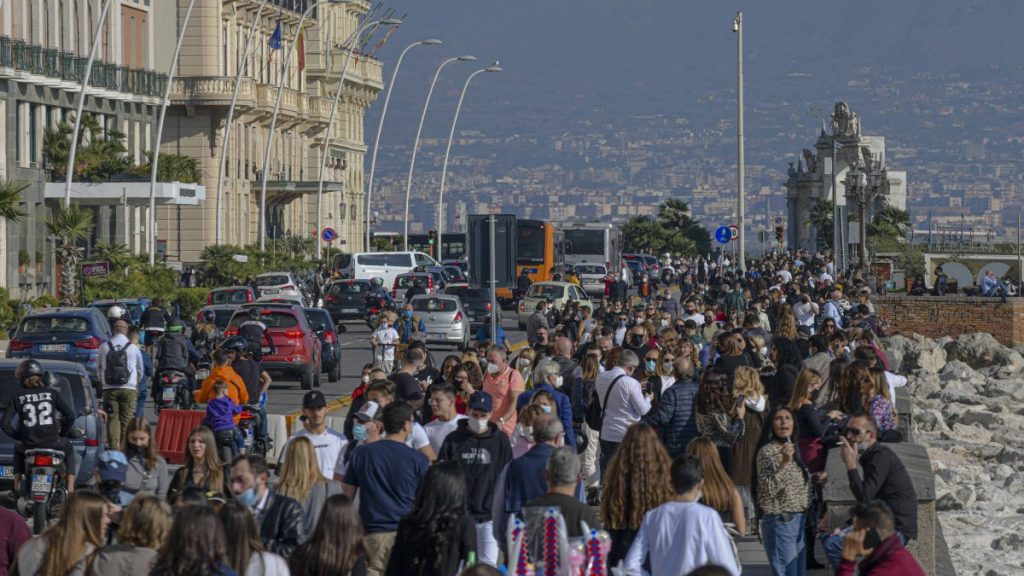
[625,456,739,576]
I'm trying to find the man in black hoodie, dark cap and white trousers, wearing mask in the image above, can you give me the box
[437,390,512,566]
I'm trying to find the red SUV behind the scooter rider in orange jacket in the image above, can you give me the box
[224,302,321,390]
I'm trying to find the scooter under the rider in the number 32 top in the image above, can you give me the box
[17,428,85,534]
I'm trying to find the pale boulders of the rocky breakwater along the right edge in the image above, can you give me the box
[886,334,1024,576]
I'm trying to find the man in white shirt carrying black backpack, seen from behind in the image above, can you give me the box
[96,320,145,450]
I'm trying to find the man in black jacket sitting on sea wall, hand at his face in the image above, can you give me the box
[824,412,918,567]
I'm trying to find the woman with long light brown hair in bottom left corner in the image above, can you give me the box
[16,490,114,576]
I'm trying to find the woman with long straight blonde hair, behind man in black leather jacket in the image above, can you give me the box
[274,436,341,534]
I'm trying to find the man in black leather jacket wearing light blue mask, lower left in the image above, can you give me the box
[231,454,305,558]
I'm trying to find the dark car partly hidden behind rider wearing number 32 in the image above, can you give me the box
[0,360,106,490]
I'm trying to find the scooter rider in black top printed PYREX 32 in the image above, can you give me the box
[0,359,78,487]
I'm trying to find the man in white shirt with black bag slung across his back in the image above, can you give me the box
[594,349,650,476]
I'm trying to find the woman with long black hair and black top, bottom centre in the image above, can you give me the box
[384,462,476,576]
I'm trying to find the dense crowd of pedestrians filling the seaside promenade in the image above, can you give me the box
[0,248,923,576]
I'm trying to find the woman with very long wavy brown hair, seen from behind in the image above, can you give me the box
[601,424,675,566]
